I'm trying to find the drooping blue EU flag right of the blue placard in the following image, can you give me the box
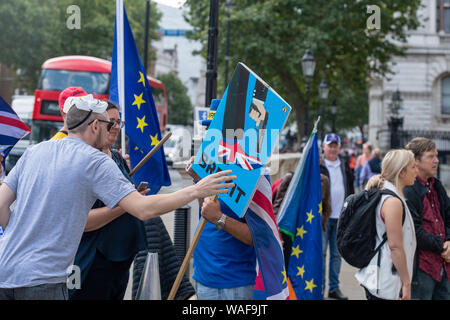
[278,131,323,300]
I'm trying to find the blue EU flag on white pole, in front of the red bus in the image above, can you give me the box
[109,3,171,194]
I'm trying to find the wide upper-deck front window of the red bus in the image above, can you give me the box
[38,69,109,94]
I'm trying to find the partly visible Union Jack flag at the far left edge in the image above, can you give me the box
[0,97,31,168]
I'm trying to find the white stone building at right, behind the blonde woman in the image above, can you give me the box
[368,0,450,182]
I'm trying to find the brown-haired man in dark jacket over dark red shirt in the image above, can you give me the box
[404,138,450,300]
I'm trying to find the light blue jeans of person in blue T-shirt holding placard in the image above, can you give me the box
[195,282,253,300]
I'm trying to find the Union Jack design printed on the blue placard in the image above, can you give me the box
[218,140,262,170]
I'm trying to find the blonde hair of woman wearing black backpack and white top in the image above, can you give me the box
[365,149,414,197]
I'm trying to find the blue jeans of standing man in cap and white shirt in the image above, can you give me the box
[322,218,341,292]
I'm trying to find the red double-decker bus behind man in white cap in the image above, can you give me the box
[31,56,167,143]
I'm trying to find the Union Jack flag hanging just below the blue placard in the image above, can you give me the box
[244,175,289,300]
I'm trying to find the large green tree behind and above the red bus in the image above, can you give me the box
[0,0,161,90]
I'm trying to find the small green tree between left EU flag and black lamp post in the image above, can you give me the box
[158,72,192,125]
